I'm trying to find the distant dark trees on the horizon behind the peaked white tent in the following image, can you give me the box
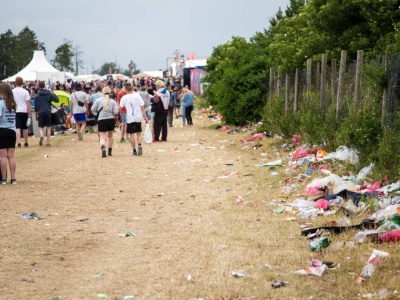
[0,26,140,80]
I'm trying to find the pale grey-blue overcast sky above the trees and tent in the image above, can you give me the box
[0,0,290,74]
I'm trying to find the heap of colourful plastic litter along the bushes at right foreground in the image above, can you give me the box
[252,136,400,283]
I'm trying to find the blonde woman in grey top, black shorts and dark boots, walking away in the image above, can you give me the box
[92,86,118,157]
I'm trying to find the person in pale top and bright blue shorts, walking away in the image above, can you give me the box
[69,82,89,141]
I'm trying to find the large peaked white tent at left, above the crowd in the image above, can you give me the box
[3,50,65,82]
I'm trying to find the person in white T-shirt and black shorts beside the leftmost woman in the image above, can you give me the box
[12,76,32,148]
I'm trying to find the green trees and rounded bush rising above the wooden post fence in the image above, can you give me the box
[204,0,400,125]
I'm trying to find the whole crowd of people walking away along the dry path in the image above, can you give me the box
[0,77,195,184]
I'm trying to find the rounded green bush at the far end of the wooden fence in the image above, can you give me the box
[204,37,268,125]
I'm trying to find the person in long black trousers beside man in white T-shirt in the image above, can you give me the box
[151,80,171,142]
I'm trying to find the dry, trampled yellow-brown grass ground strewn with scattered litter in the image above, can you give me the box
[0,114,400,300]
